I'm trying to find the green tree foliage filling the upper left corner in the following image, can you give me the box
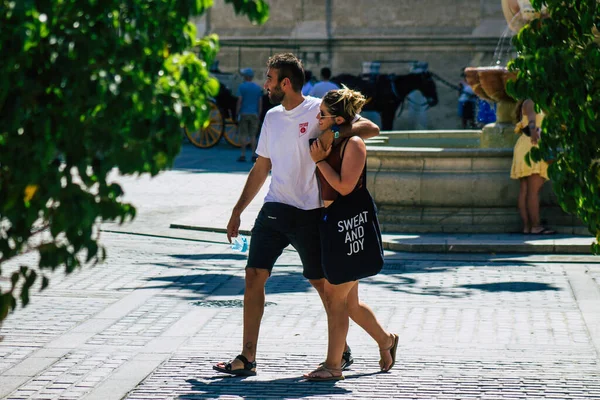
[0,0,269,321]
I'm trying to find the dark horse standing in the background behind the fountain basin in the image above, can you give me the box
[331,72,438,131]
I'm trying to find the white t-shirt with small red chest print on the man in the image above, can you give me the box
[256,97,323,210]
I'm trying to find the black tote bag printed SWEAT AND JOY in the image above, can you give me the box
[319,165,383,285]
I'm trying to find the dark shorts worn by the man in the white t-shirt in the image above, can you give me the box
[246,203,325,279]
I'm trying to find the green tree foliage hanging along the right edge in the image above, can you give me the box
[507,0,600,254]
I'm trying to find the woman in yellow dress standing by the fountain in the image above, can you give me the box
[510,99,556,235]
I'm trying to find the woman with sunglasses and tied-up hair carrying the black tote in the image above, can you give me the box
[304,86,398,381]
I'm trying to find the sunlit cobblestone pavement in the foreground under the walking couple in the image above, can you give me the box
[0,233,600,399]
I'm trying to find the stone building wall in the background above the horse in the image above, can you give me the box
[196,0,510,129]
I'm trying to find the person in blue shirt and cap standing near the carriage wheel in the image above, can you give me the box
[235,68,262,162]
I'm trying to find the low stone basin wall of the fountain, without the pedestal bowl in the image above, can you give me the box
[367,146,586,234]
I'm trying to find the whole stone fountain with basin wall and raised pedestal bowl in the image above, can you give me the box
[367,0,586,234]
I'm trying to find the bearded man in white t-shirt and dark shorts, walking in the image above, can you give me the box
[213,53,379,376]
